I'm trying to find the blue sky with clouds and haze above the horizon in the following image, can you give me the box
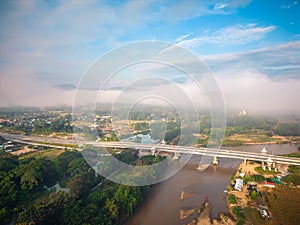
[0,0,300,112]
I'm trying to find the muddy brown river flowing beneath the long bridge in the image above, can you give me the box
[125,144,299,225]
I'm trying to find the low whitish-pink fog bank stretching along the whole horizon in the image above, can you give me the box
[0,74,300,115]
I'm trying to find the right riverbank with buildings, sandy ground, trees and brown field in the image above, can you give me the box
[226,155,300,225]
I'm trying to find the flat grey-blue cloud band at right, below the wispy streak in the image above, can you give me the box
[202,41,300,80]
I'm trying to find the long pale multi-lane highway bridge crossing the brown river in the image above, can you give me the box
[0,133,300,166]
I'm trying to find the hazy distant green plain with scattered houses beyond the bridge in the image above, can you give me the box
[0,106,300,146]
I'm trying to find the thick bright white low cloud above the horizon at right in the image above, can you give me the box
[217,70,300,114]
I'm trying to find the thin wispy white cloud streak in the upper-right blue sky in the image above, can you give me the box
[178,24,276,48]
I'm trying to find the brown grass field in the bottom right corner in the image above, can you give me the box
[264,187,300,225]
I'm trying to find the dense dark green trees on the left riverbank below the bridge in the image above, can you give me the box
[0,146,163,225]
